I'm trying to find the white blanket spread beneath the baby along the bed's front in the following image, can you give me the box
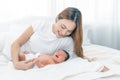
[0,58,116,80]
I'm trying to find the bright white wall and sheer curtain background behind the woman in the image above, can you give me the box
[0,0,120,49]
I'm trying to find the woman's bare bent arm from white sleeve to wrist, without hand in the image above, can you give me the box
[11,26,33,63]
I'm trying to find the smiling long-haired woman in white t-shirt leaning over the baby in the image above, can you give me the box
[11,7,84,70]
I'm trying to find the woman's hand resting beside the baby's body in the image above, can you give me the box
[14,59,35,70]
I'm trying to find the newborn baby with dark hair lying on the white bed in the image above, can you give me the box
[19,50,69,68]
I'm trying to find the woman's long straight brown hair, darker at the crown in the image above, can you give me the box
[56,7,84,58]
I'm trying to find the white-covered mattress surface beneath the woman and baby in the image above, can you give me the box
[0,45,120,80]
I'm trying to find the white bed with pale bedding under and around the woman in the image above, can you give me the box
[0,18,120,80]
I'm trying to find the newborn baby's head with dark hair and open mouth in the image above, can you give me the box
[53,50,69,63]
